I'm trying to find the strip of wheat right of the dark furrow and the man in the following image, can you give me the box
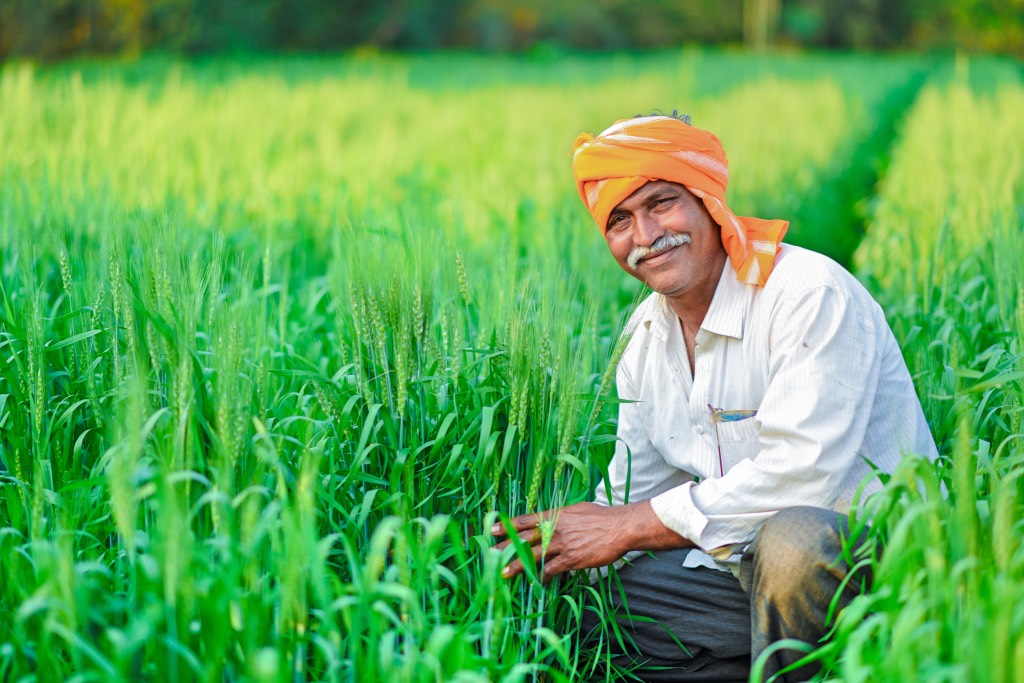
[819,65,1024,682]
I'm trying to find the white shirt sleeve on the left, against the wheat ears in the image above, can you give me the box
[594,352,693,505]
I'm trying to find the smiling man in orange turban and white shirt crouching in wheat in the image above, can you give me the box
[493,116,935,681]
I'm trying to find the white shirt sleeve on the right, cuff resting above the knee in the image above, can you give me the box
[651,287,882,550]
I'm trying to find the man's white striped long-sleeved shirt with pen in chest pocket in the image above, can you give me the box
[597,245,937,568]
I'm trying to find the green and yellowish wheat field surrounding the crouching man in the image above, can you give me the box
[0,49,1024,683]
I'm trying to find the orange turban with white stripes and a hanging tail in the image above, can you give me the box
[572,116,790,287]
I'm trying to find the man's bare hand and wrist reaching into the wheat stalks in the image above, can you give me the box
[490,501,693,581]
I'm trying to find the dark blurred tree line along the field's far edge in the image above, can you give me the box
[0,0,1024,59]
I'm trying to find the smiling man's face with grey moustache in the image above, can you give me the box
[604,180,725,296]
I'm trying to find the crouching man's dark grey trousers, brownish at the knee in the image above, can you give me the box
[584,507,870,683]
